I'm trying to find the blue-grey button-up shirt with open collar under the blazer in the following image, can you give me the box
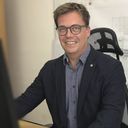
[63,46,90,128]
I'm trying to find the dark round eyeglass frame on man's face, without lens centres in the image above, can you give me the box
[56,24,87,36]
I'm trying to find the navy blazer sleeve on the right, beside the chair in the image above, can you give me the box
[88,62,126,128]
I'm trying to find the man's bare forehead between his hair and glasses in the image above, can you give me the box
[57,11,85,26]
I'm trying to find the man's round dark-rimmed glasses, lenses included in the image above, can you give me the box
[57,24,86,36]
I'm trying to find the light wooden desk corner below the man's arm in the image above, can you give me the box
[19,120,48,128]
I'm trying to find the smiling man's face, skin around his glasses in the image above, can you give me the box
[58,11,90,55]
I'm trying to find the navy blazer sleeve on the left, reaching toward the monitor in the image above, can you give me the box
[15,69,45,118]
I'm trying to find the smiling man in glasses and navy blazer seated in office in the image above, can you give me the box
[16,3,125,128]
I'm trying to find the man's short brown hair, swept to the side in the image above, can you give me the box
[54,2,90,27]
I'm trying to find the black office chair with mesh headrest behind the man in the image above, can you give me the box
[88,28,128,128]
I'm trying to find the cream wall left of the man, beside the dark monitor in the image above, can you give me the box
[5,0,54,124]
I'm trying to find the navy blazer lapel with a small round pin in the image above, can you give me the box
[77,48,96,118]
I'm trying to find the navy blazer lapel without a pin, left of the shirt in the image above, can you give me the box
[56,58,67,127]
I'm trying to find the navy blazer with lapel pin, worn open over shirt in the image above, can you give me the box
[16,47,126,128]
